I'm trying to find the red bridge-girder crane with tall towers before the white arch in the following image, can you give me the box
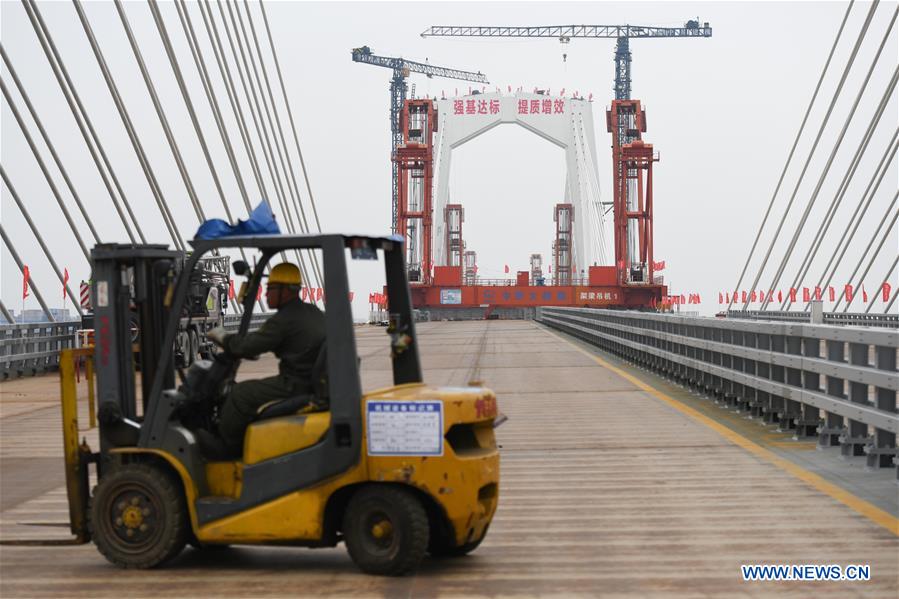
[394,99,667,317]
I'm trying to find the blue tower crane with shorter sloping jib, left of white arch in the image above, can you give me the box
[353,46,489,233]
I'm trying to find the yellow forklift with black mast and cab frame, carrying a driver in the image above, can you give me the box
[63,235,499,575]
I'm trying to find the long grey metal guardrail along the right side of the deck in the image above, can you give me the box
[536,308,899,476]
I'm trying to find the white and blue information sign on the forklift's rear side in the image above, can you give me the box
[365,400,443,456]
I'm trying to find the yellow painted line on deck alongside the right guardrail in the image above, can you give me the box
[544,329,899,536]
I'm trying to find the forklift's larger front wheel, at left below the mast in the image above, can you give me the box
[88,464,188,568]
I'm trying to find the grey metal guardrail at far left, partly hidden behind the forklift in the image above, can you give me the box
[0,313,271,380]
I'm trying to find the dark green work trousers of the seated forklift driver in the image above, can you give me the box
[219,374,312,454]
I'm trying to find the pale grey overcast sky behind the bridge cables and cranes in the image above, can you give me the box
[0,1,899,313]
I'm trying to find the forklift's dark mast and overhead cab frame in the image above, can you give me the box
[92,234,422,524]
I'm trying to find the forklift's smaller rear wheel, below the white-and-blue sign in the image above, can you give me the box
[343,485,429,576]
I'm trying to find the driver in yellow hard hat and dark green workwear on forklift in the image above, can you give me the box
[202,262,325,456]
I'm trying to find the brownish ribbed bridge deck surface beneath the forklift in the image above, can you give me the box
[0,321,899,597]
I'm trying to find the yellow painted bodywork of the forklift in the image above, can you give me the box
[113,384,499,545]
